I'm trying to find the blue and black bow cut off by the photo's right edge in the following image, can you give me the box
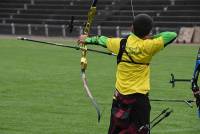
[191,48,200,118]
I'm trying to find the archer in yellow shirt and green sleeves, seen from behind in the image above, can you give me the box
[78,14,177,134]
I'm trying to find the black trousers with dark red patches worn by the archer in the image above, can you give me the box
[108,91,151,134]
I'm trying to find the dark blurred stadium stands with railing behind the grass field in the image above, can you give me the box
[0,0,200,43]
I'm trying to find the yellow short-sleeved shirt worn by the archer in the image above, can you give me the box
[106,34,164,95]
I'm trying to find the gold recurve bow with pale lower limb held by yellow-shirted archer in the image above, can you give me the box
[81,0,101,122]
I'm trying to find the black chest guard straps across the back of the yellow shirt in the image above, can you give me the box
[117,39,149,65]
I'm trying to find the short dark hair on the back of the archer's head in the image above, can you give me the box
[133,14,153,38]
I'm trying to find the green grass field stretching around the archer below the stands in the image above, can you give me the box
[0,39,200,134]
